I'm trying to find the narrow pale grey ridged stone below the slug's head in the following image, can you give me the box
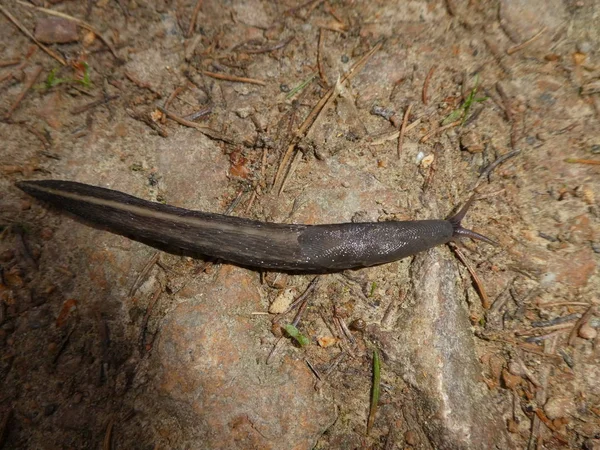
[376,248,508,449]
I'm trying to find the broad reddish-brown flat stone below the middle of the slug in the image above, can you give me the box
[155,266,335,449]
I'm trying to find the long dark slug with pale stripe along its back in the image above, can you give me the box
[17,180,493,273]
